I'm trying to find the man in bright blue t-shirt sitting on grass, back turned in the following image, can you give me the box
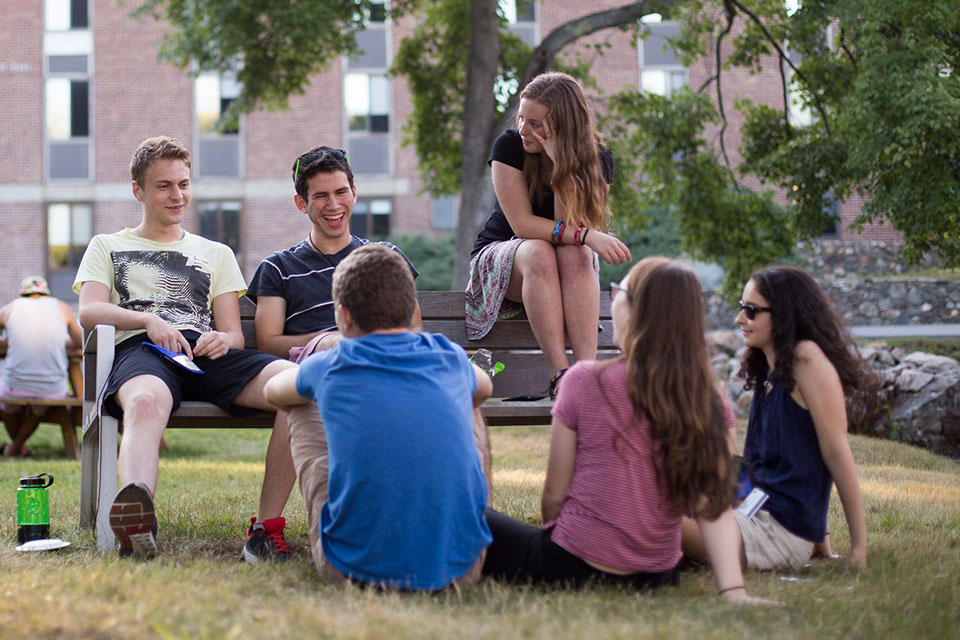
[265,245,493,590]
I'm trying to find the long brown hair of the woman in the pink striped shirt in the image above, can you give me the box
[621,256,733,518]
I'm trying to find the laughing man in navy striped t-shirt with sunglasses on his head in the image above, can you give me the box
[243,147,421,563]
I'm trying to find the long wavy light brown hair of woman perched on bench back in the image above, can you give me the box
[520,72,612,231]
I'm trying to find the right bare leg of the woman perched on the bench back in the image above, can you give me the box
[556,246,600,360]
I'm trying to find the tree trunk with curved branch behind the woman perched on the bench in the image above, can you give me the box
[452,0,652,291]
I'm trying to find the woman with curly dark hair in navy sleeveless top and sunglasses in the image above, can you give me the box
[683,267,867,569]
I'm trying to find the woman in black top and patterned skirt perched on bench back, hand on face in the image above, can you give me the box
[466,73,630,395]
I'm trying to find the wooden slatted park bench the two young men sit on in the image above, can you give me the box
[80,291,616,553]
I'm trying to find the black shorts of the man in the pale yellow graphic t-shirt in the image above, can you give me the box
[104,331,280,420]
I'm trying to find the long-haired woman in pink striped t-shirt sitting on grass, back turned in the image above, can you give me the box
[484,257,770,603]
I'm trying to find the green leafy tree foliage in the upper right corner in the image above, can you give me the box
[612,0,960,294]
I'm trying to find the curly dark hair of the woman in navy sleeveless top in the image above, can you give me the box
[737,266,866,393]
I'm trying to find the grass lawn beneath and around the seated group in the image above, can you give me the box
[0,425,960,640]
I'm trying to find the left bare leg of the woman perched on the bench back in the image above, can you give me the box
[506,240,568,377]
